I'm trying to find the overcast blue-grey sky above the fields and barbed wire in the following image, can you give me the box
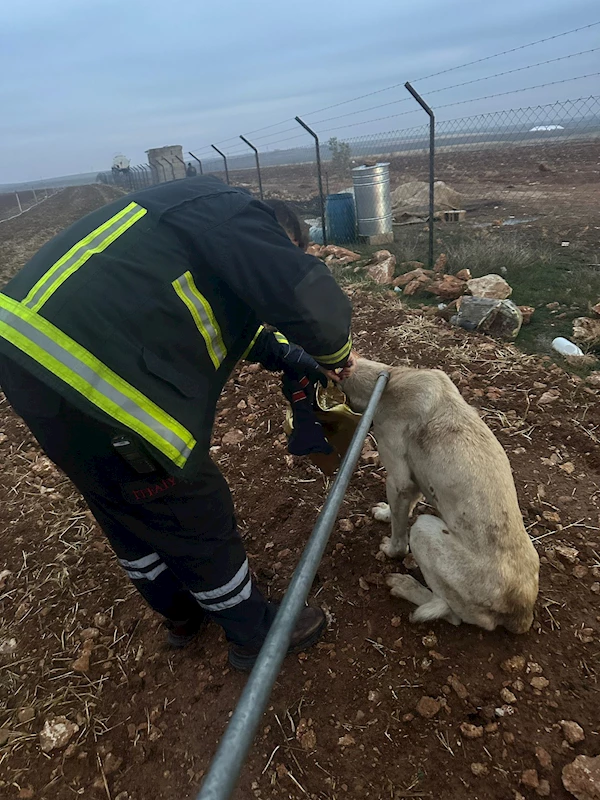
[0,0,600,184]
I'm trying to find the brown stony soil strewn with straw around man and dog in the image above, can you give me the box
[0,187,600,800]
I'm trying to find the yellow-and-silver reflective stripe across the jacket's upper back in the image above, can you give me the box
[23,203,147,311]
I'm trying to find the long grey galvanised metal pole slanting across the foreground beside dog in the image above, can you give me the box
[196,372,390,800]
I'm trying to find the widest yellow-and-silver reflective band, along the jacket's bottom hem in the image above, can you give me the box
[0,294,196,467]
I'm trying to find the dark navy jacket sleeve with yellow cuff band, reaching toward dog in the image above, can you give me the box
[171,193,352,368]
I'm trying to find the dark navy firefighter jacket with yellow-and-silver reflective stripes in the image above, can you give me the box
[0,177,351,478]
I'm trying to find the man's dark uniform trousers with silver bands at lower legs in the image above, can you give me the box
[0,359,275,645]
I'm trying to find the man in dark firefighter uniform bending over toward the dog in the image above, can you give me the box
[0,177,351,670]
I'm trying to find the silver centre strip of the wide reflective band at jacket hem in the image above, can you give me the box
[0,308,192,460]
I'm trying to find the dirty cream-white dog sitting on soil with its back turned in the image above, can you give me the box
[341,358,539,633]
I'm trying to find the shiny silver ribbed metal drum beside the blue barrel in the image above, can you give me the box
[352,162,393,236]
